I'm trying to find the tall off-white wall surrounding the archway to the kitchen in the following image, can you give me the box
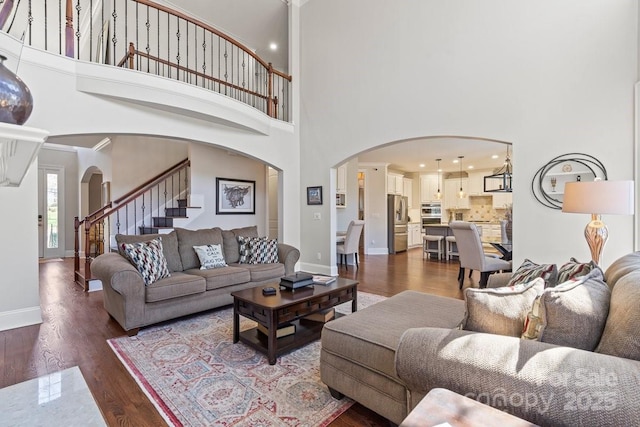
[300,0,638,274]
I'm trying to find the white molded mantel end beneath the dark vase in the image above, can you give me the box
[0,123,49,187]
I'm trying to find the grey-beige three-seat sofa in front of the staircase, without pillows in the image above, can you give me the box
[91,226,300,335]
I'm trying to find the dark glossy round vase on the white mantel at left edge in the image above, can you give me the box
[0,55,33,125]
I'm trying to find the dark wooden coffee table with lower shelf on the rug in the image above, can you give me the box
[231,277,358,365]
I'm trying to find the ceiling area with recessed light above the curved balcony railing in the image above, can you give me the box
[162,0,289,73]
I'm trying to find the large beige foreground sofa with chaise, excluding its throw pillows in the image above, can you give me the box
[320,252,640,427]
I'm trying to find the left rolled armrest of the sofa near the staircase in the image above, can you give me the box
[91,252,146,331]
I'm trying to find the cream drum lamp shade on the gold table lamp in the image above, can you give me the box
[562,181,634,215]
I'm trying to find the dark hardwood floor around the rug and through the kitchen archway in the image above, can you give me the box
[0,248,478,427]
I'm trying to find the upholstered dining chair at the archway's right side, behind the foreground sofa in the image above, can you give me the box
[449,221,511,289]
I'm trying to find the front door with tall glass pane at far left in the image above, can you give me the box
[38,167,64,258]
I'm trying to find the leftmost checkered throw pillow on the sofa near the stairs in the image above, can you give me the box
[121,237,170,286]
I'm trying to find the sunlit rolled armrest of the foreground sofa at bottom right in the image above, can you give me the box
[396,328,640,426]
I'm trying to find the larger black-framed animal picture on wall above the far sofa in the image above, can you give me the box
[216,178,256,215]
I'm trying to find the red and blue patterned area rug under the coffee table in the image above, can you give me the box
[108,292,385,427]
